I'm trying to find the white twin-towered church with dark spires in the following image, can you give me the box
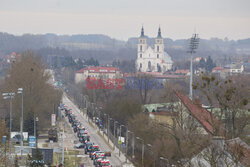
[136,27,173,73]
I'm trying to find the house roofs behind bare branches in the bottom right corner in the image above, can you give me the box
[187,136,250,167]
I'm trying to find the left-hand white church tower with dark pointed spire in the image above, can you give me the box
[136,27,148,71]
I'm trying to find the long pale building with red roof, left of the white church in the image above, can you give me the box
[75,66,123,83]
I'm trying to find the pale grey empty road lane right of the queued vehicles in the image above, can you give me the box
[62,95,122,167]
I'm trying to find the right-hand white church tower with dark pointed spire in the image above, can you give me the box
[154,27,164,60]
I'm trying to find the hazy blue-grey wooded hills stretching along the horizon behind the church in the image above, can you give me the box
[0,32,250,63]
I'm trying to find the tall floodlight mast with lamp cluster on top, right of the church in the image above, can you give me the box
[188,34,199,100]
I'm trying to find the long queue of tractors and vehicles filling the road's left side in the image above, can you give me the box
[63,105,112,167]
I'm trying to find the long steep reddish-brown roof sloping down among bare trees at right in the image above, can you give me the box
[174,91,222,135]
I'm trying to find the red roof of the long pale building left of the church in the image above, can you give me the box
[77,66,122,73]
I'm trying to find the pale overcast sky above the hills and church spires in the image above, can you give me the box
[0,0,250,40]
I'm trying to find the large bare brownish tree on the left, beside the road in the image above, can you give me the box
[2,52,62,133]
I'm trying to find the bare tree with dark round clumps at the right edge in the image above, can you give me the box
[193,74,250,138]
